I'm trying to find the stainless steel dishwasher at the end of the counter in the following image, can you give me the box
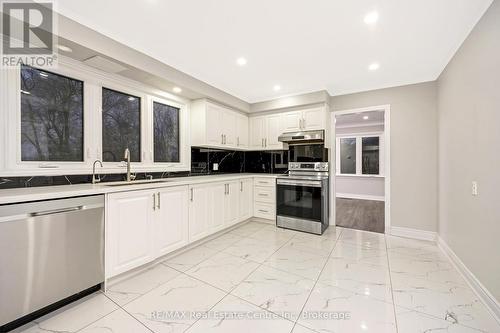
[0,195,104,332]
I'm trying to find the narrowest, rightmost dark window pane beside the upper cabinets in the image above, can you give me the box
[153,102,180,162]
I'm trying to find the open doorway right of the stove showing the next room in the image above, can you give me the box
[331,105,390,233]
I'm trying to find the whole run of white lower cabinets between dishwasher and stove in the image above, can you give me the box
[105,177,282,278]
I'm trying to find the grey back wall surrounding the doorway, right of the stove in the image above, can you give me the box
[330,82,438,231]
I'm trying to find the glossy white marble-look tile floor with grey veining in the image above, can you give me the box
[13,222,500,333]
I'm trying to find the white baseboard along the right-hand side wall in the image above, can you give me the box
[438,236,500,323]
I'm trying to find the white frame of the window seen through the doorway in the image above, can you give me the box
[335,132,385,177]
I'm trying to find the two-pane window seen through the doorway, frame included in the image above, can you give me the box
[337,135,383,175]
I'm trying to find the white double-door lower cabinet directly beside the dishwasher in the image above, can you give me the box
[106,186,188,277]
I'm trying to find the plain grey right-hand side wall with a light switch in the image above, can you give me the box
[438,0,500,301]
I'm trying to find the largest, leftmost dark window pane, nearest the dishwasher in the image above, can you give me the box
[21,66,83,162]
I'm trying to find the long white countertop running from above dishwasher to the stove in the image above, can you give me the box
[0,173,278,205]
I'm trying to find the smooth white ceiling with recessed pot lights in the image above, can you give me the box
[57,0,492,103]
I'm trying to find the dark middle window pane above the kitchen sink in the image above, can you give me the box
[102,88,141,162]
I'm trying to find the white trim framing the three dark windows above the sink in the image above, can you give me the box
[0,56,191,177]
